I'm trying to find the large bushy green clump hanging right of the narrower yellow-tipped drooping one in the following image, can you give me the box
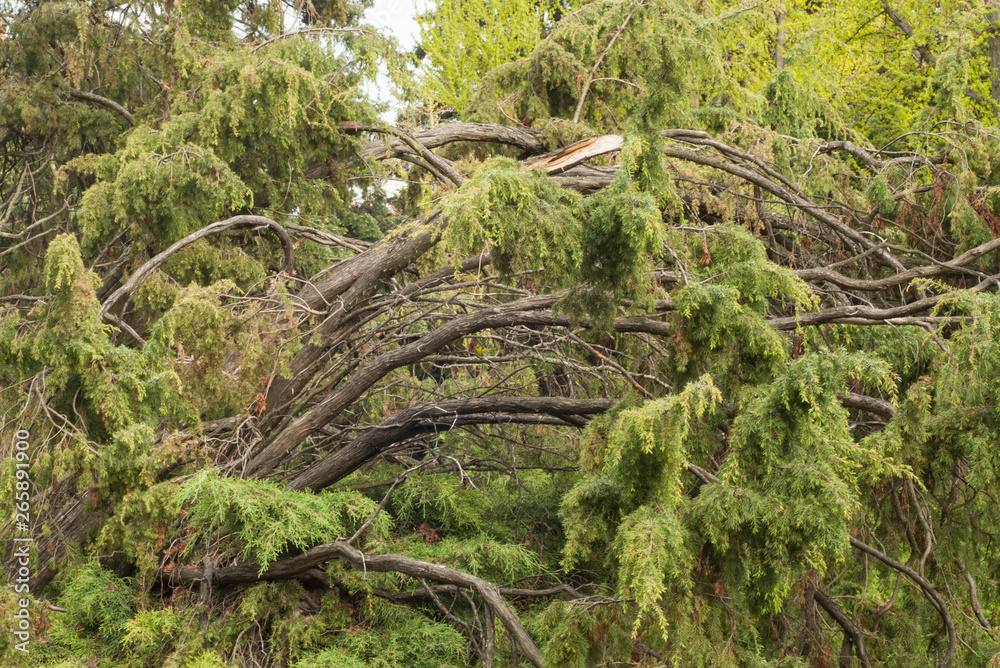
[694,351,895,611]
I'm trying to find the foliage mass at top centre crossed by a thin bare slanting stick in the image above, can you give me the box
[468,0,718,129]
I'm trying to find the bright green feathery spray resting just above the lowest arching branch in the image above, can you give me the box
[175,469,391,572]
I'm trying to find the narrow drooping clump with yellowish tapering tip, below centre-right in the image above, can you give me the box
[562,376,722,634]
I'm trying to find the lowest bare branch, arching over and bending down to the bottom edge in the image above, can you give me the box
[160,541,542,666]
